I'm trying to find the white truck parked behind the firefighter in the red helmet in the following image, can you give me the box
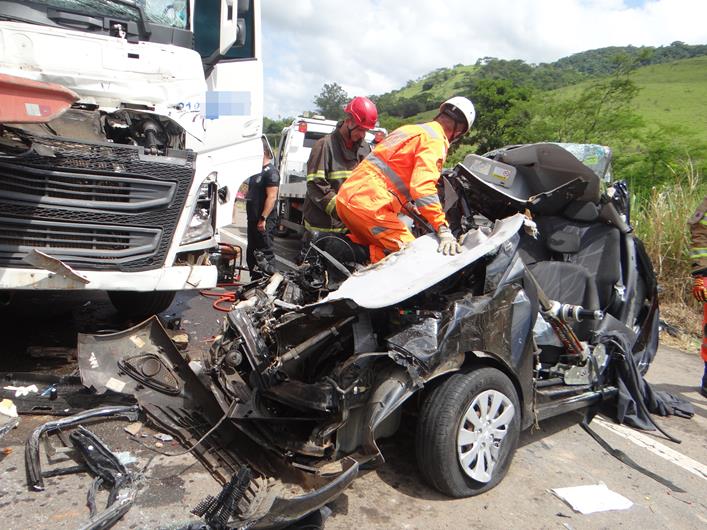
[276,115,388,237]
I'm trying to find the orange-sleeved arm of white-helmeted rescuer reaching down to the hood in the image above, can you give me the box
[410,138,447,232]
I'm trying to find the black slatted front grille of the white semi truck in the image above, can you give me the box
[0,134,195,272]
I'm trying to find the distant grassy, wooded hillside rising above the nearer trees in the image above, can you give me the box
[372,42,707,141]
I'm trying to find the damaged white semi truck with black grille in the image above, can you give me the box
[0,0,263,315]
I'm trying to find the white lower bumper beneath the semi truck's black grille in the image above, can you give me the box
[0,266,217,291]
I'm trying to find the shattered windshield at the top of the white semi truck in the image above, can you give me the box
[32,0,189,29]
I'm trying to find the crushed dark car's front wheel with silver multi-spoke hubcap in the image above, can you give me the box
[416,368,520,497]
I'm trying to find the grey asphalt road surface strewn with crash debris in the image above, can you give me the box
[0,286,707,529]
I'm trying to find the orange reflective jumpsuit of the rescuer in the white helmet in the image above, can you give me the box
[336,121,449,263]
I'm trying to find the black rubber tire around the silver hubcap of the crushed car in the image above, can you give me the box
[415,368,521,497]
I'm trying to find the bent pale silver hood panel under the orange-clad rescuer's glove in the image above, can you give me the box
[316,214,525,309]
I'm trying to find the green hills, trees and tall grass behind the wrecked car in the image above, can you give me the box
[276,42,707,323]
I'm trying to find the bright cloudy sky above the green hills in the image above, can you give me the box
[262,0,707,118]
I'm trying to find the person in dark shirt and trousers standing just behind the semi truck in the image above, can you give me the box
[246,138,280,280]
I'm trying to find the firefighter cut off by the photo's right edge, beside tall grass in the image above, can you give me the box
[688,197,707,397]
